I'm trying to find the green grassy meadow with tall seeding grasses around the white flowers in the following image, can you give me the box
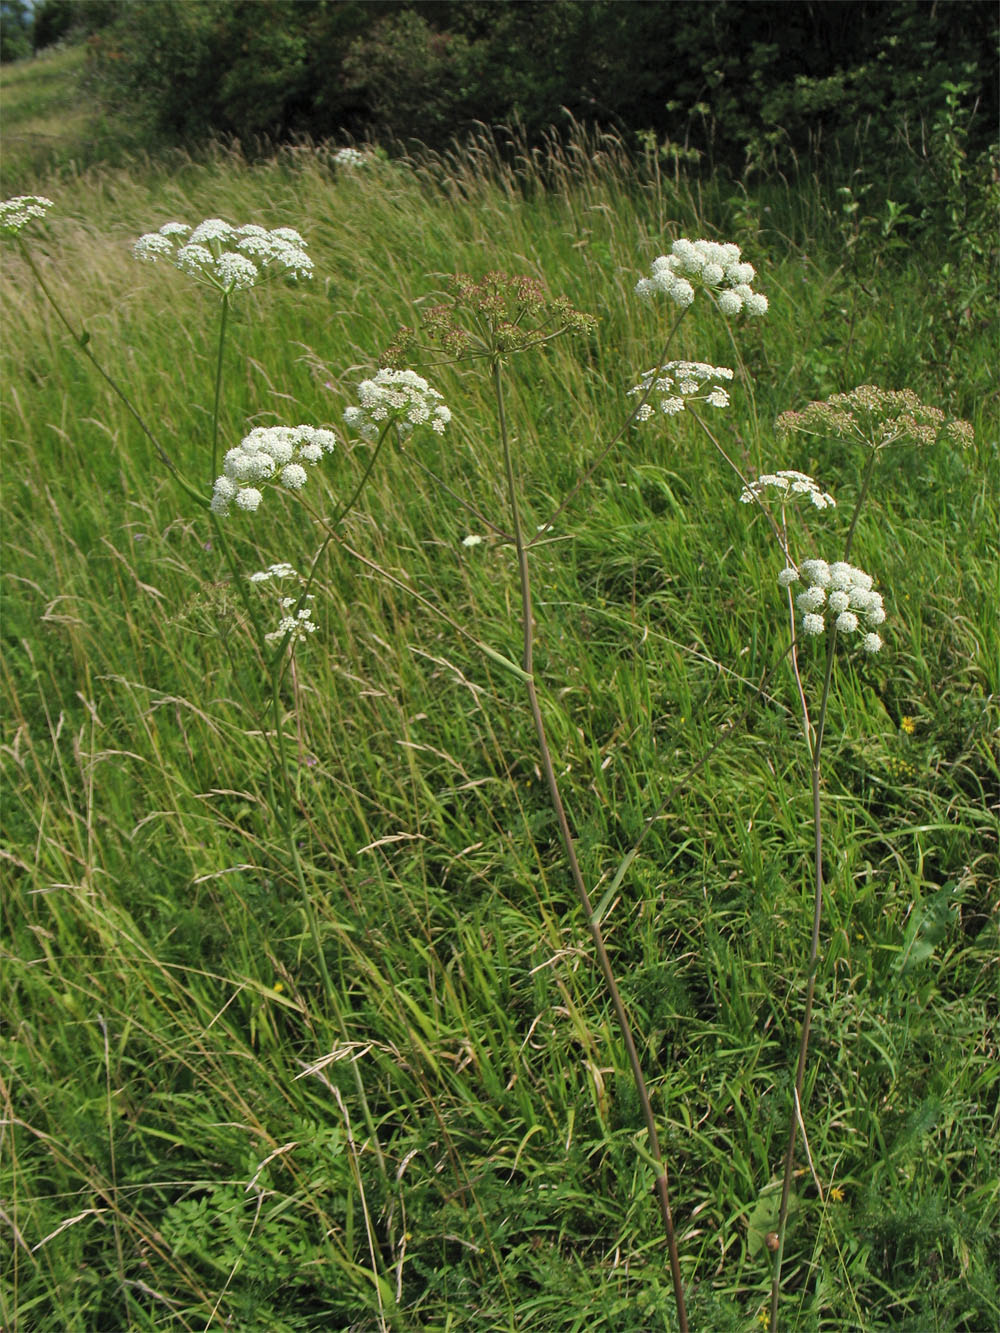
[0,51,1000,1333]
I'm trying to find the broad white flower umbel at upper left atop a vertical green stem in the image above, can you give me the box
[132,217,312,292]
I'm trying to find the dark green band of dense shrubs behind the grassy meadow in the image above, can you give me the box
[84,0,999,182]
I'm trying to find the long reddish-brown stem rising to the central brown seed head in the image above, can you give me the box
[493,359,688,1333]
